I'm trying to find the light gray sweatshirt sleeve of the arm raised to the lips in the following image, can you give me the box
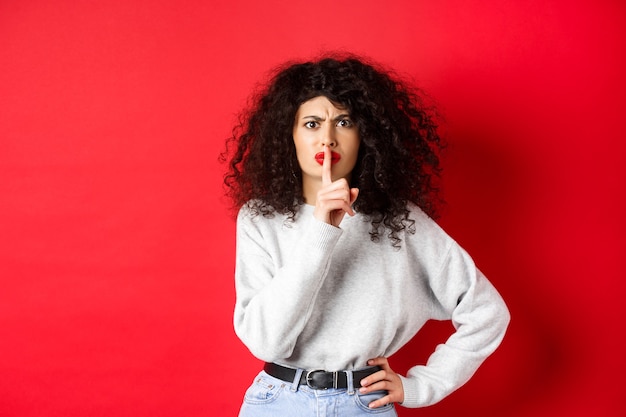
[234,210,342,362]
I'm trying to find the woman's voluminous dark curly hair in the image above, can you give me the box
[221,55,443,246]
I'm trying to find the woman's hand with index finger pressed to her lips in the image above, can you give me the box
[313,145,359,227]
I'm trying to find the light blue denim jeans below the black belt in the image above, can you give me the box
[239,371,398,417]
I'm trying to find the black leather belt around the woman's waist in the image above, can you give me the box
[263,362,382,389]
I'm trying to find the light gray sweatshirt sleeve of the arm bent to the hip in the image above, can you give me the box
[401,242,510,408]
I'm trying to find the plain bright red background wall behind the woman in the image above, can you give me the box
[0,0,626,417]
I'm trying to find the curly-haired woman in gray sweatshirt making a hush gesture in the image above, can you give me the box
[225,53,509,417]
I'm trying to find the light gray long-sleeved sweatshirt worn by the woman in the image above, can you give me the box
[234,205,510,407]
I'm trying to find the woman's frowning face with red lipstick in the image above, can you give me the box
[293,96,361,188]
